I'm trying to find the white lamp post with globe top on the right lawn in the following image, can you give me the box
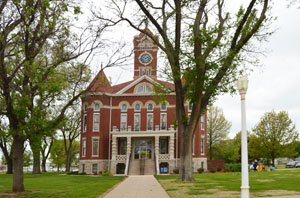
[237,77,249,198]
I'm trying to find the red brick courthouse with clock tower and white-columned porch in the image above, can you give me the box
[80,30,207,175]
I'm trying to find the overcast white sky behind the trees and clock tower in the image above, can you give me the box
[93,0,300,138]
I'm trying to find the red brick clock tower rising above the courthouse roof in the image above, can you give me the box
[133,29,158,79]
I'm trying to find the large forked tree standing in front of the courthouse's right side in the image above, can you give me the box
[95,0,270,181]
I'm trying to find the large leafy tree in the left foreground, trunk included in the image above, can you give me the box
[0,0,101,192]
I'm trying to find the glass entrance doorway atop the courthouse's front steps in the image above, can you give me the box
[134,140,152,159]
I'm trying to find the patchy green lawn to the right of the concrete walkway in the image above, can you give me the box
[156,168,300,198]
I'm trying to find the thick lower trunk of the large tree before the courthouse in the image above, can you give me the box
[178,132,194,181]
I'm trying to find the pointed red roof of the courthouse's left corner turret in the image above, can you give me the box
[87,69,112,93]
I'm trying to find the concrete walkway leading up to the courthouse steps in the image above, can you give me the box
[103,175,169,198]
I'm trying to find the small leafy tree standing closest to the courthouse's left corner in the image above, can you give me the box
[61,109,81,172]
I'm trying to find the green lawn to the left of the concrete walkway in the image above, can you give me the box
[0,173,124,198]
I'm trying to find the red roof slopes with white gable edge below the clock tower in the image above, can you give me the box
[114,75,175,95]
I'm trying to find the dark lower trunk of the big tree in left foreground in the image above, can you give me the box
[12,135,25,192]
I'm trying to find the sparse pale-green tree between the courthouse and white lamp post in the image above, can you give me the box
[207,106,231,160]
